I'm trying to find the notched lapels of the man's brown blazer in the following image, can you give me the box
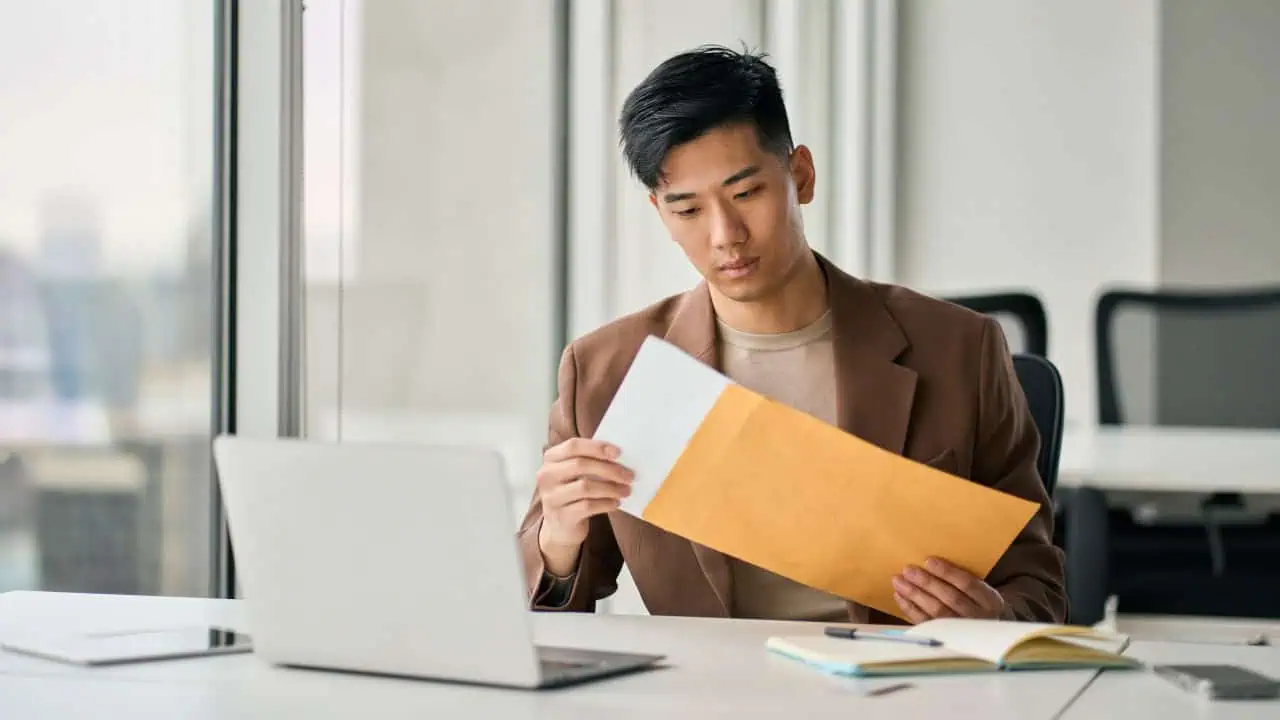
[664,252,916,615]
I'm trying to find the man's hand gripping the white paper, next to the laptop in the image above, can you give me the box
[538,438,635,577]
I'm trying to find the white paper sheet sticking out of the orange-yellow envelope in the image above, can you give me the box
[595,337,730,518]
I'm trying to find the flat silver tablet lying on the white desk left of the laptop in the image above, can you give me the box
[0,625,252,666]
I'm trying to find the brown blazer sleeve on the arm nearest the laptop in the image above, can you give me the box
[516,345,622,612]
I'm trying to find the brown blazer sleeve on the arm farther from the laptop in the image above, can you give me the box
[973,318,1068,623]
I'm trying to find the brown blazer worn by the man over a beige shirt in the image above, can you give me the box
[518,256,1066,623]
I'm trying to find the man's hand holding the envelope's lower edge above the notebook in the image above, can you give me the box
[893,557,1005,624]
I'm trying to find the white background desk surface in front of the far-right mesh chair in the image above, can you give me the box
[1059,425,1280,493]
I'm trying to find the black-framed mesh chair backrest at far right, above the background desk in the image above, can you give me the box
[1094,287,1280,428]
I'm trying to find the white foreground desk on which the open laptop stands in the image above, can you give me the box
[0,592,1093,720]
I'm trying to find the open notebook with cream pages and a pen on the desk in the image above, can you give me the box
[767,619,1138,676]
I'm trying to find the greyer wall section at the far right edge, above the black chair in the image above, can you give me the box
[1160,0,1280,286]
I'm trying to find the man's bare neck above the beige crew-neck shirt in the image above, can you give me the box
[710,252,827,334]
